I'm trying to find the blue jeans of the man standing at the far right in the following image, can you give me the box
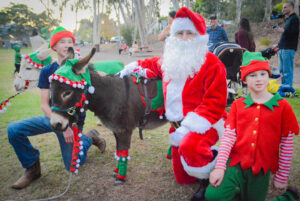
[279,50,295,87]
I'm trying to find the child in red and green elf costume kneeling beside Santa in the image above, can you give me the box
[205,52,299,201]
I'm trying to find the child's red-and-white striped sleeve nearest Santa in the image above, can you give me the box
[215,125,236,170]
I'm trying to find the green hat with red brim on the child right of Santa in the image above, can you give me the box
[241,51,272,81]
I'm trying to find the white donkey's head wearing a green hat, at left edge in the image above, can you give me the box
[14,44,51,91]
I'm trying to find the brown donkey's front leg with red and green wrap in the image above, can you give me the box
[114,132,132,184]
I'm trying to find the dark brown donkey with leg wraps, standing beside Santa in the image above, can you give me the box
[50,48,166,184]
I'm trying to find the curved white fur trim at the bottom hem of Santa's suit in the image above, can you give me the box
[180,146,218,179]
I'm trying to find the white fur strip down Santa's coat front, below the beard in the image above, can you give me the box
[166,80,185,121]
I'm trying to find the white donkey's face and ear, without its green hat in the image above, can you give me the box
[14,45,51,92]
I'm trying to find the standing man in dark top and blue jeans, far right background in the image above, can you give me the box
[275,1,299,88]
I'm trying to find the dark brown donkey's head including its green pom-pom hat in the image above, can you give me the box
[49,48,96,132]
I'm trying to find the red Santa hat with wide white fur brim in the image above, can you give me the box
[170,7,206,35]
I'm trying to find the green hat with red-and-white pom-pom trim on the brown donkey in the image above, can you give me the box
[49,59,95,94]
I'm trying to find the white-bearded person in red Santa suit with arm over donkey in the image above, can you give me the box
[120,7,227,200]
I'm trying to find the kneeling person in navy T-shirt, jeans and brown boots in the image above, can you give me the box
[7,27,105,189]
